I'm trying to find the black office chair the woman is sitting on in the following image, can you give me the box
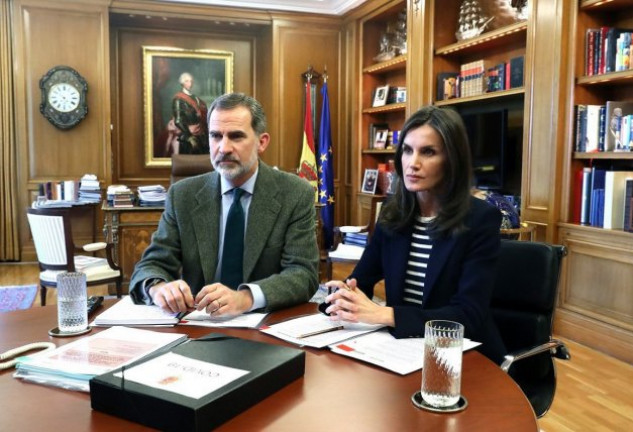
[491,240,570,417]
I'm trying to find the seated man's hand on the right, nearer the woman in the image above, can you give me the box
[196,283,253,316]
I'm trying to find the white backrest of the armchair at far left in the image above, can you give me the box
[26,208,75,271]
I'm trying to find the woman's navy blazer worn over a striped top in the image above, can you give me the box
[350,197,506,363]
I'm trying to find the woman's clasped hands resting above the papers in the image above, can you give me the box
[325,279,395,327]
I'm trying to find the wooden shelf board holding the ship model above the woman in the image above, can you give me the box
[435,21,527,56]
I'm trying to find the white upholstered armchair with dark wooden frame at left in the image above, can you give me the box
[27,208,122,306]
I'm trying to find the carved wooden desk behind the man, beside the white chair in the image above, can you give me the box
[101,201,163,293]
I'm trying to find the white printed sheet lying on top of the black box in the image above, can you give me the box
[114,352,250,399]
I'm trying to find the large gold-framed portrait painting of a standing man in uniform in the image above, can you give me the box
[143,46,233,167]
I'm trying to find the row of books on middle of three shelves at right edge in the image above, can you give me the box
[574,101,633,152]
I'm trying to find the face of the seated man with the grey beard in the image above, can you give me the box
[209,107,270,187]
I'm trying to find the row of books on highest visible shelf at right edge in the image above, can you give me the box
[585,27,633,76]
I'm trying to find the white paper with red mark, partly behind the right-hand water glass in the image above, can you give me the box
[330,330,481,375]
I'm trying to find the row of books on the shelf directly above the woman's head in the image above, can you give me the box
[437,56,525,100]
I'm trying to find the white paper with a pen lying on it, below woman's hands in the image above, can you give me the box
[260,313,384,348]
